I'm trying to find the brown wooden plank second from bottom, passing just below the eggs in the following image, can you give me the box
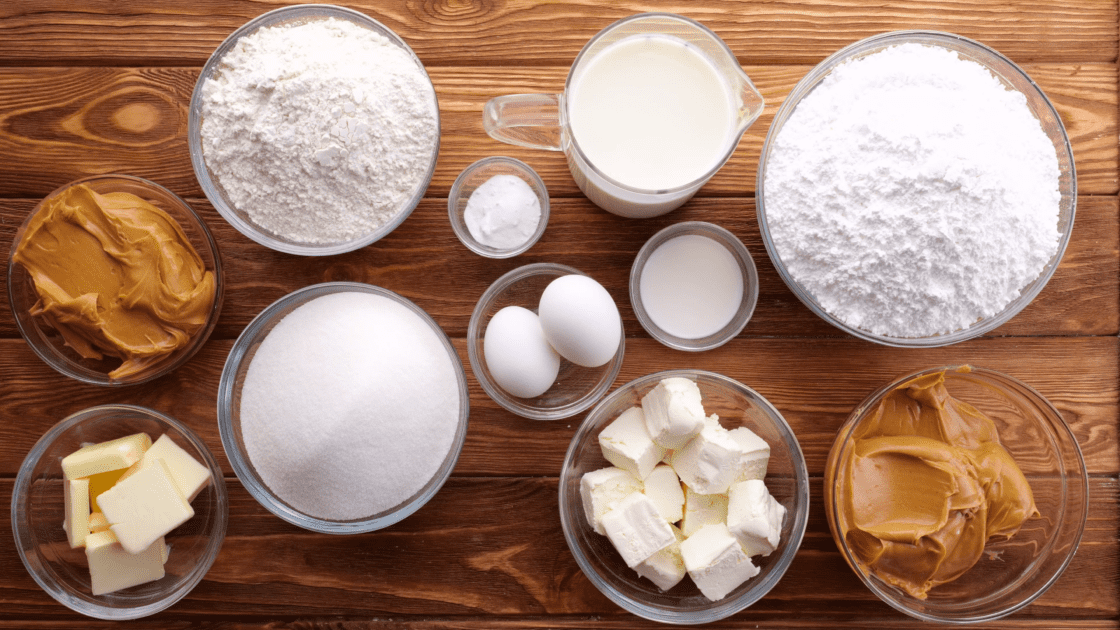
[0,336,1120,476]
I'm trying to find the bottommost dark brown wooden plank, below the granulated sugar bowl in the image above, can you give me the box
[0,478,1120,628]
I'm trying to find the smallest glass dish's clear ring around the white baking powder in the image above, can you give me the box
[447,156,549,258]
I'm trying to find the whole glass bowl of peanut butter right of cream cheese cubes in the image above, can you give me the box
[824,365,1089,623]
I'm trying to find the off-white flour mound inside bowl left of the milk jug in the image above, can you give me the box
[200,18,439,244]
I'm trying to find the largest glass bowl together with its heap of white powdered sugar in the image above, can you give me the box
[757,30,1077,348]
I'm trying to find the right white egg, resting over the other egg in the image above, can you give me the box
[538,274,623,368]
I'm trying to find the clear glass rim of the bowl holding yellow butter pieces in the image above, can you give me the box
[11,404,230,621]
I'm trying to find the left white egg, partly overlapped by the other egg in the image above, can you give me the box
[483,306,560,398]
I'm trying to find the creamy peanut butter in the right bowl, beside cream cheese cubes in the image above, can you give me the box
[825,367,1038,600]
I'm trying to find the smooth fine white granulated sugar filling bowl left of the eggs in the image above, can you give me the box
[241,291,459,520]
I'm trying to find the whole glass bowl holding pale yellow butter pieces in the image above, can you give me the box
[11,405,228,620]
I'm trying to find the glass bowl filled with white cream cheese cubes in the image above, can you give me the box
[560,370,809,624]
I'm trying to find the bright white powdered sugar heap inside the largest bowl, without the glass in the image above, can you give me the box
[764,44,1061,337]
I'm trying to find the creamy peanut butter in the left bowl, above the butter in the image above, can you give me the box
[13,185,215,379]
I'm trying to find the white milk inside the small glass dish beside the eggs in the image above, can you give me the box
[638,234,743,339]
